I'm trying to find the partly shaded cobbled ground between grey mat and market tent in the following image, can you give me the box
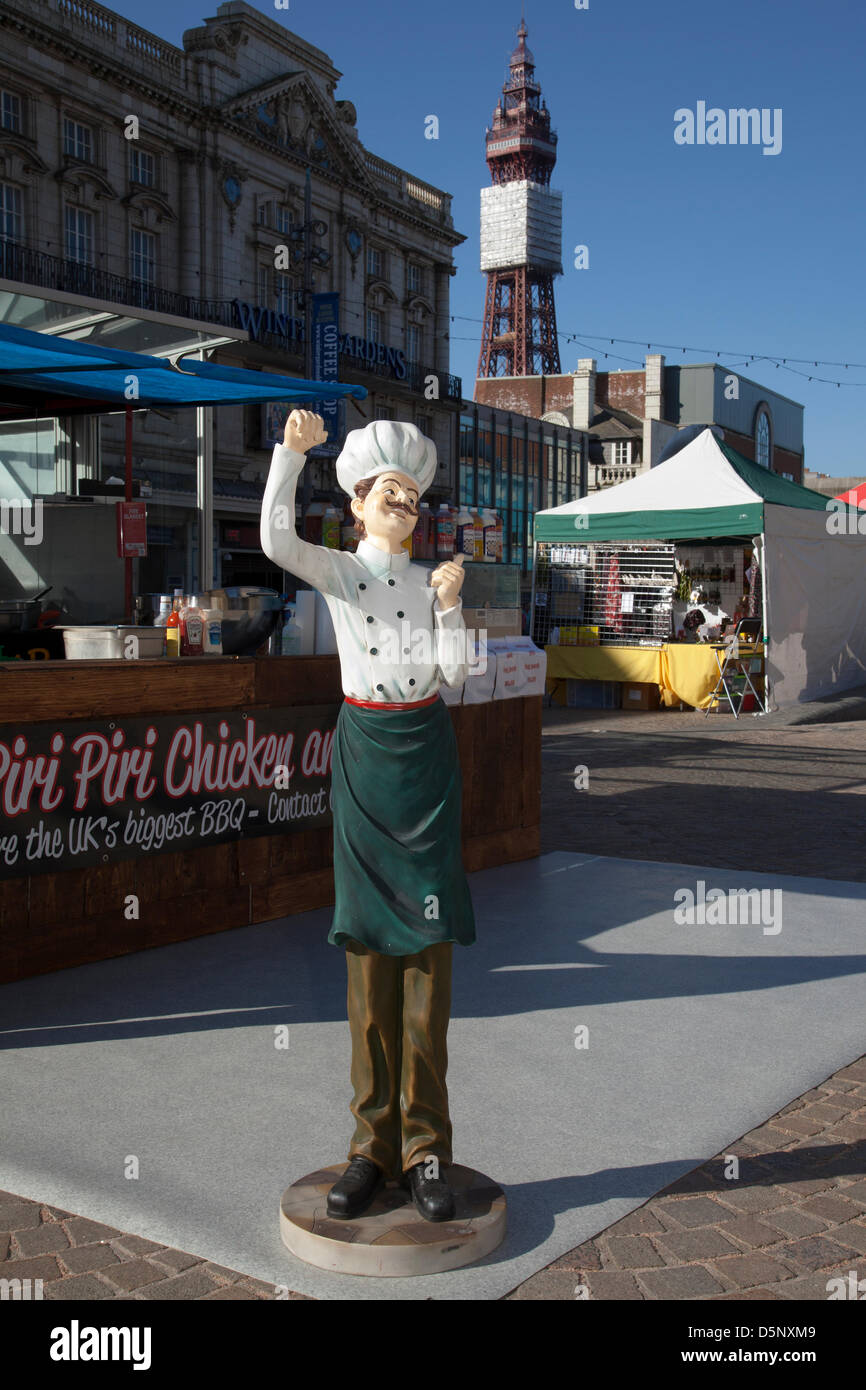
[541,708,866,883]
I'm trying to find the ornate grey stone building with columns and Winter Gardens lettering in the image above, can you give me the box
[0,0,464,592]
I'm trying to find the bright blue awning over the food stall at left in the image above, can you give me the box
[0,324,367,420]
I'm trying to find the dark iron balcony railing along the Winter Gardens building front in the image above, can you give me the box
[0,240,463,400]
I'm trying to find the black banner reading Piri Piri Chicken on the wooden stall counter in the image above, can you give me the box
[0,705,339,878]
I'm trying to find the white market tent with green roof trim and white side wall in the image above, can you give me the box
[535,428,866,708]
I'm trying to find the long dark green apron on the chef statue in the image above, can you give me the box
[328,699,475,956]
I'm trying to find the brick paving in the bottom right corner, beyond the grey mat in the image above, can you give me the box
[506,1056,866,1302]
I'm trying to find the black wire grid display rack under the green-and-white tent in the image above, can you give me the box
[532,541,677,646]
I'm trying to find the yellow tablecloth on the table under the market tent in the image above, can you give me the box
[545,642,719,709]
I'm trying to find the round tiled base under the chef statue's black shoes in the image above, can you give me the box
[279,1163,506,1277]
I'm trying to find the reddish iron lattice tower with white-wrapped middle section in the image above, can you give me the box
[478,19,563,377]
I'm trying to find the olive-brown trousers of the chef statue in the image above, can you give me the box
[346,940,453,1180]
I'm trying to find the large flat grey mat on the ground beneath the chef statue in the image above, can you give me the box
[0,853,866,1300]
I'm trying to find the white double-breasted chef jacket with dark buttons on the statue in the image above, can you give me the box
[261,443,467,703]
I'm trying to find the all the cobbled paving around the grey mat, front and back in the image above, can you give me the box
[0,706,866,1301]
